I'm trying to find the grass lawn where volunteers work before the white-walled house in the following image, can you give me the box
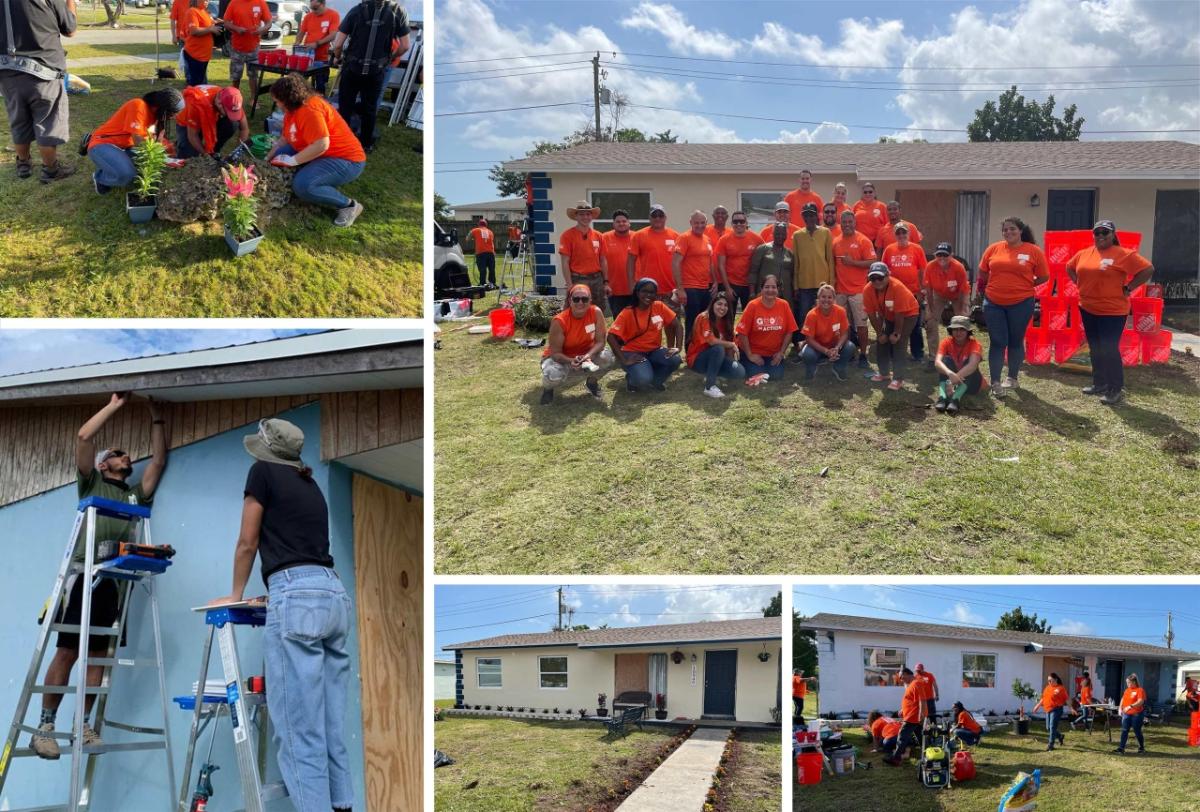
[792,722,1200,812]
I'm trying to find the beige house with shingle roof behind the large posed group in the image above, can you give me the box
[504,142,1200,301]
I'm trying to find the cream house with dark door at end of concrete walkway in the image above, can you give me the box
[443,618,782,723]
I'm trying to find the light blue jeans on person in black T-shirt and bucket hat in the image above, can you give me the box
[263,565,354,812]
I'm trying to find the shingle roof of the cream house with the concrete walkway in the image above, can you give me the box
[442,618,782,651]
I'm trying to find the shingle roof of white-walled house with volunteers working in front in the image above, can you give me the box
[800,612,1198,660]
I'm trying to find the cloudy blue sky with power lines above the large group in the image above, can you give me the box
[436,0,1200,203]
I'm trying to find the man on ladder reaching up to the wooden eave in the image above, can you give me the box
[30,392,167,759]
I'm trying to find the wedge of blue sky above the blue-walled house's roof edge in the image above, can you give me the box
[0,329,319,375]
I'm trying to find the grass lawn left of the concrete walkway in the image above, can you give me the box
[433,717,676,812]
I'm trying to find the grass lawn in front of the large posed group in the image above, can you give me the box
[434,321,1200,575]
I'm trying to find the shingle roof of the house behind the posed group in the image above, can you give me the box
[504,142,1200,180]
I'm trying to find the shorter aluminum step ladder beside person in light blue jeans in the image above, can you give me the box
[175,601,288,812]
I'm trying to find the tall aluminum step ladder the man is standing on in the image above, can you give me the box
[0,497,175,812]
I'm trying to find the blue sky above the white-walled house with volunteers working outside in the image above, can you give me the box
[792,583,1200,651]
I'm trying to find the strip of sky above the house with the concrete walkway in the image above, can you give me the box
[433,583,780,658]
